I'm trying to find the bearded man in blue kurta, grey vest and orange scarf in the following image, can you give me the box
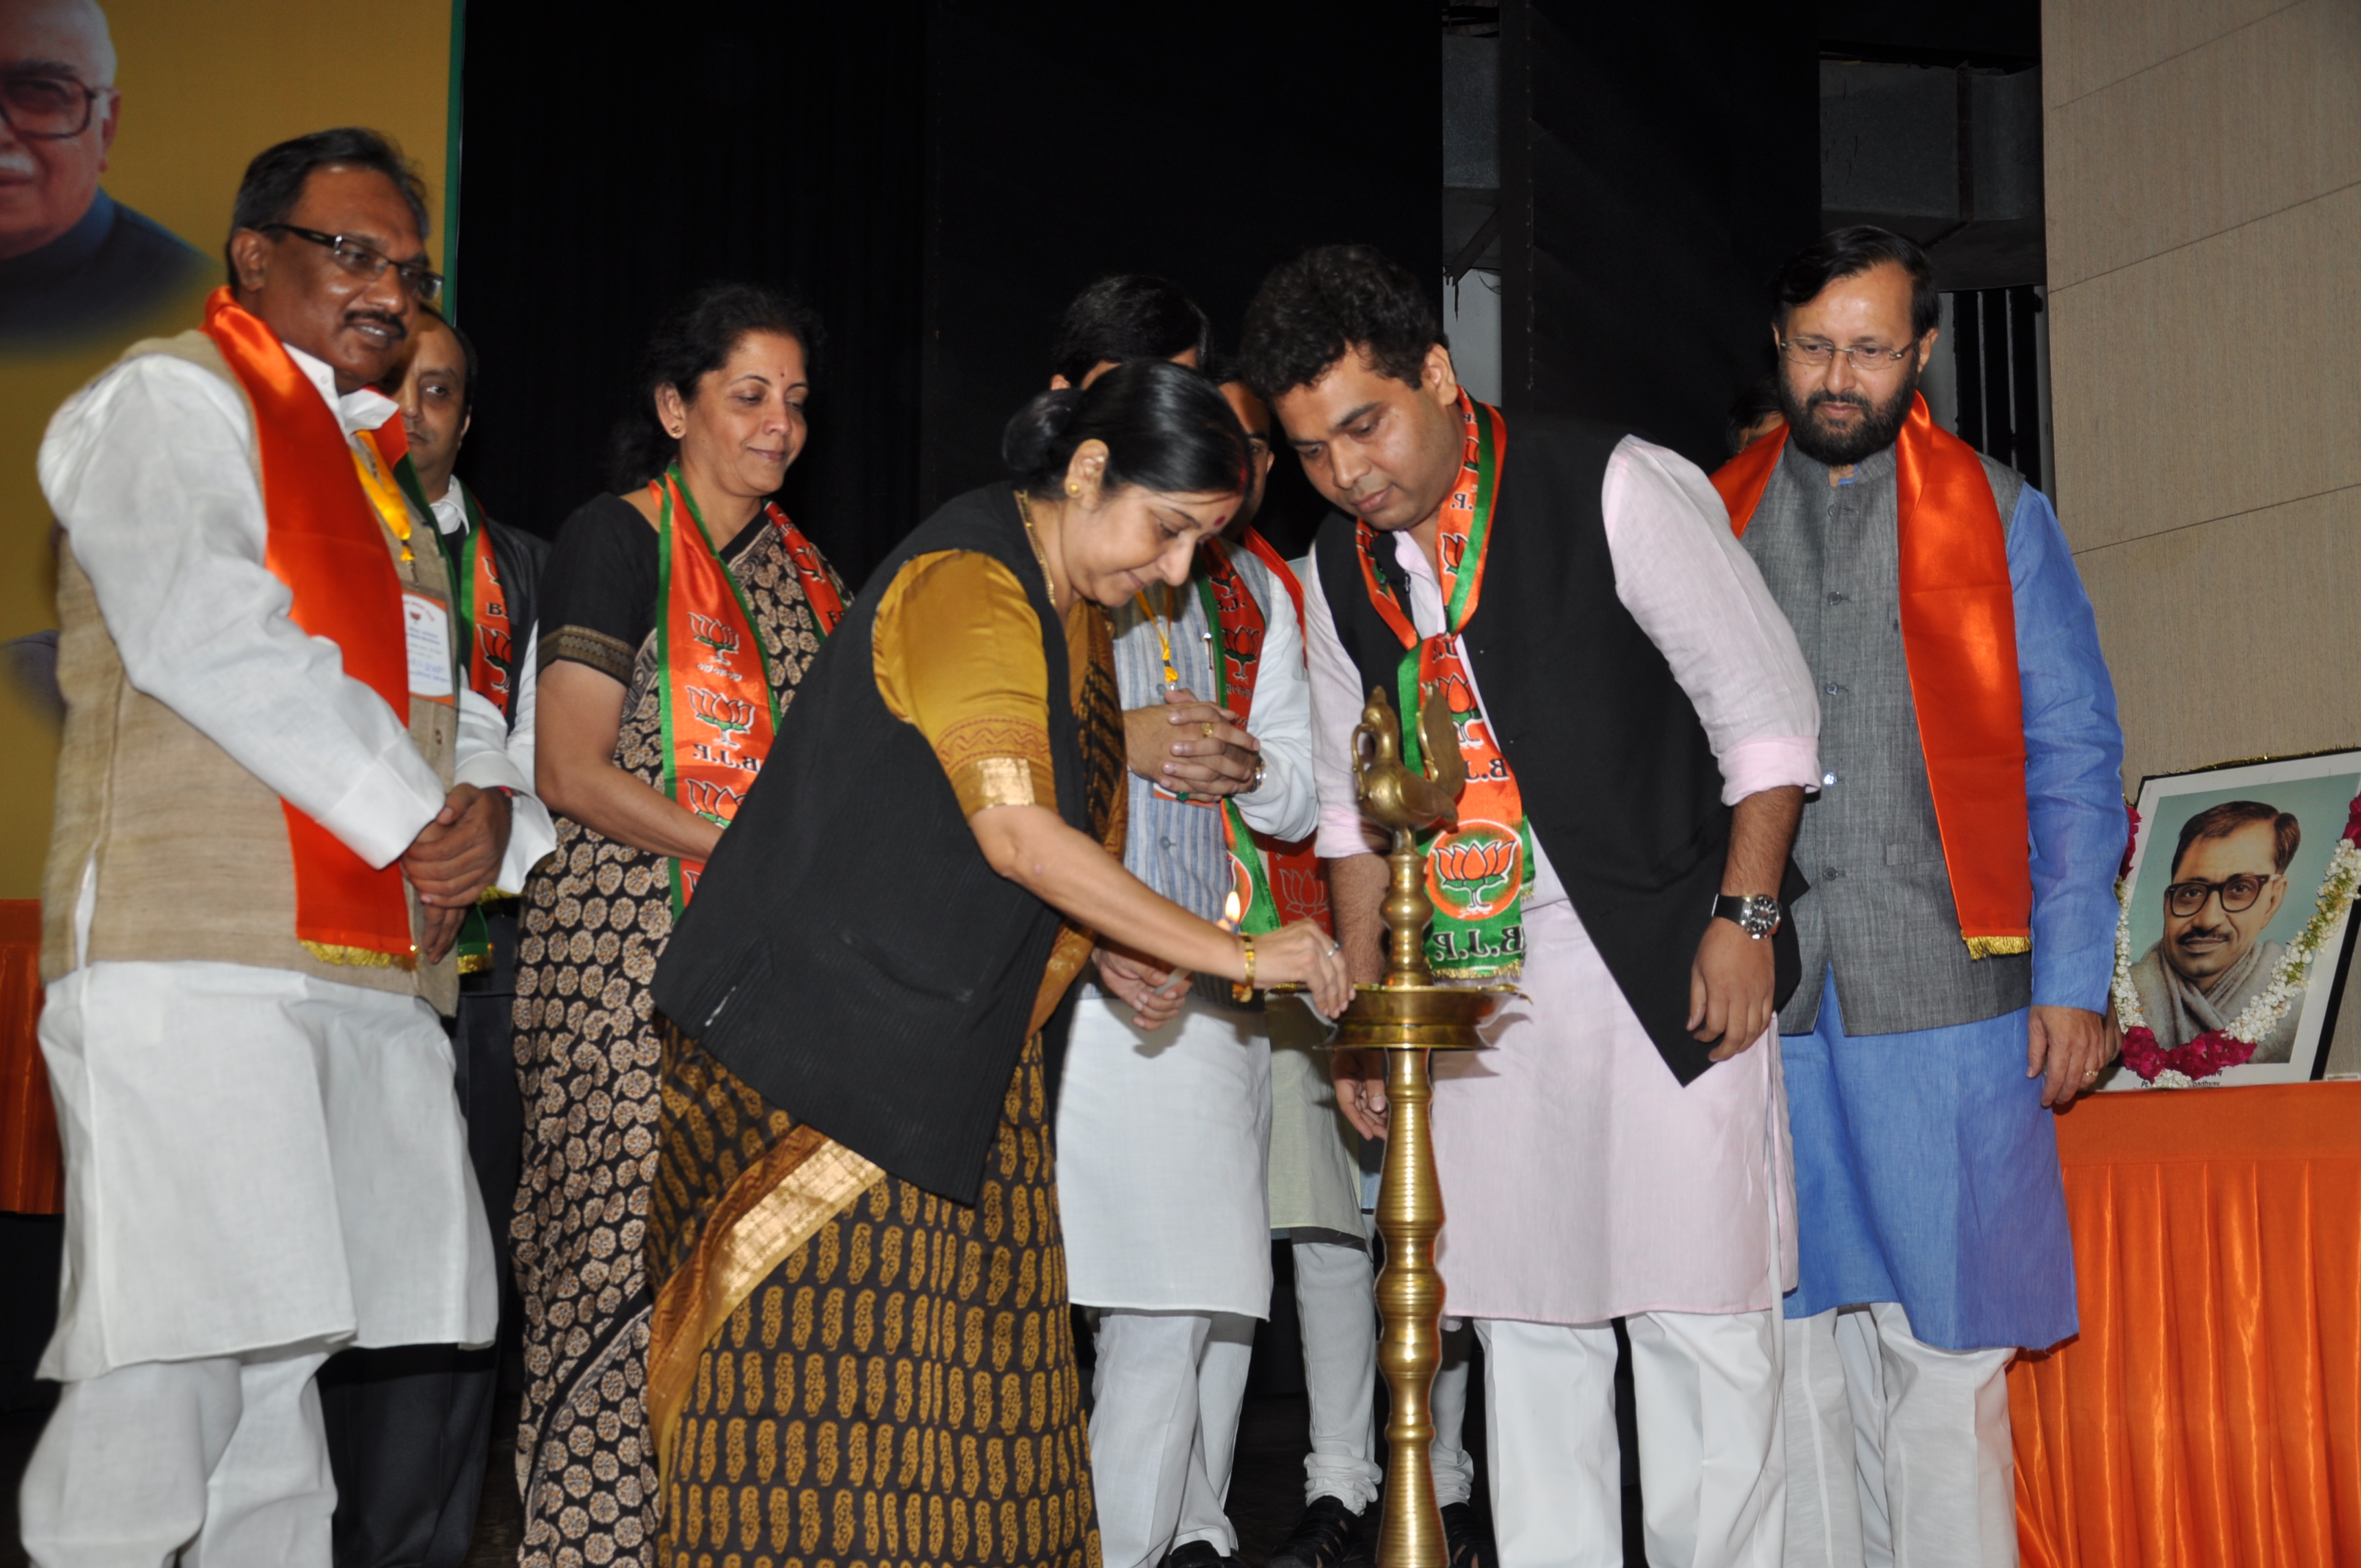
[1714,227,2125,1568]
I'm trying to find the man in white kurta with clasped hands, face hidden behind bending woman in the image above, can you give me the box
[1058,377,1318,1568]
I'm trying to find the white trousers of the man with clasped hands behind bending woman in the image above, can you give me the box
[1091,1313,1254,1568]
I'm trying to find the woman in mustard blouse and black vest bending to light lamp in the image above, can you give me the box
[647,363,1351,1568]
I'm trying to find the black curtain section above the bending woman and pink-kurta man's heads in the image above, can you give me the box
[923,0,1443,551]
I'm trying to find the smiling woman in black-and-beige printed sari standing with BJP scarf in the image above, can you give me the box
[510,283,843,1566]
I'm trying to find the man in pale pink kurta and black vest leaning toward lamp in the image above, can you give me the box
[1247,248,1818,1568]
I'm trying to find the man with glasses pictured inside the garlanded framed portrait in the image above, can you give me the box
[2132,801,2304,1063]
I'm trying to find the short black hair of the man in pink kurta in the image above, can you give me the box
[1237,246,1443,409]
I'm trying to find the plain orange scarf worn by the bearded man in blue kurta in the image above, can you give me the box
[1714,394,2033,959]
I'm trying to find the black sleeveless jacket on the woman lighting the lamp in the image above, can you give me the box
[654,484,1091,1205]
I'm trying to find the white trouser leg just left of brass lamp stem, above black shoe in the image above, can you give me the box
[1289,1242,1386,1514]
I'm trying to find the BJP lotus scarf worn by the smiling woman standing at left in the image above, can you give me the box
[647,463,845,918]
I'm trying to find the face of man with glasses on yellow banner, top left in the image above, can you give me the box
[0,0,120,258]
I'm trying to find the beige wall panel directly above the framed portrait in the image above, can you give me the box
[2075,487,2361,791]
